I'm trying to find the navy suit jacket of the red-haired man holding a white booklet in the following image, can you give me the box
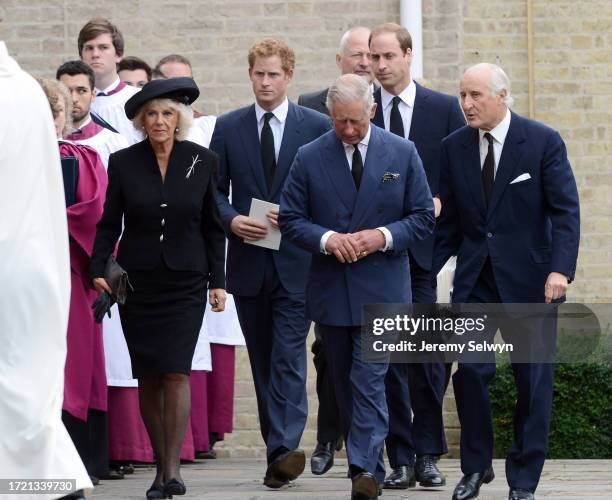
[210,102,331,296]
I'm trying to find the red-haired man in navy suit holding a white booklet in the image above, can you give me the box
[210,38,330,488]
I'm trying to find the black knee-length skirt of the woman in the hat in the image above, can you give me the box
[119,259,207,378]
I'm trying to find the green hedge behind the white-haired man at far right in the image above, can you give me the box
[491,363,612,459]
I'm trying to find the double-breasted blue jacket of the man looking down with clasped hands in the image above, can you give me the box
[279,125,434,326]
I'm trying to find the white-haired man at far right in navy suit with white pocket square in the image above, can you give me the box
[433,63,580,500]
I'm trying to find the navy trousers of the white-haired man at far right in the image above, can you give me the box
[453,259,556,492]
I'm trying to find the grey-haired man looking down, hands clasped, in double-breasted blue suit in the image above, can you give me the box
[279,74,434,500]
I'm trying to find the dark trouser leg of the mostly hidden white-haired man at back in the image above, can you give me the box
[311,324,341,443]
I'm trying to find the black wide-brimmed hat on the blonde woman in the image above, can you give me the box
[125,77,200,120]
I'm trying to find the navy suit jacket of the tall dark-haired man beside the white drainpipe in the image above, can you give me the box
[372,82,465,269]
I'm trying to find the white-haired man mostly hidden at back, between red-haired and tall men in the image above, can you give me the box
[298,26,375,475]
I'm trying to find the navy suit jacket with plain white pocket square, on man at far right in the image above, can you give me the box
[432,113,580,303]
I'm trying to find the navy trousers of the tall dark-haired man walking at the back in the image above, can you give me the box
[385,256,448,468]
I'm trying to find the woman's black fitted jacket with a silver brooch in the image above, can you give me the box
[90,139,225,288]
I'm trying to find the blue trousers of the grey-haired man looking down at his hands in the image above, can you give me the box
[319,325,389,484]
